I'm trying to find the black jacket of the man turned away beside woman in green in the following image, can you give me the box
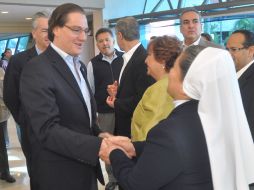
[114,45,154,137]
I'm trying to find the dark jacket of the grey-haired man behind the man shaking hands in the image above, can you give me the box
[3,46,38,178]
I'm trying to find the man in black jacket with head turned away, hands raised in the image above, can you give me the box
[107,17,154,137]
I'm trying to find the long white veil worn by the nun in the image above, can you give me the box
[183,47,254,190]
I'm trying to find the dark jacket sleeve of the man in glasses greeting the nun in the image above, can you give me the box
[20,59,101,166]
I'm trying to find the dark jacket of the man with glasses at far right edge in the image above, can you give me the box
[238,63,254,139]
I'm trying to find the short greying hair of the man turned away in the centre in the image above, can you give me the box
[116,17,140,41]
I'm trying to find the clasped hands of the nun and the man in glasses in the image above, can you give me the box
[99,133,136,164]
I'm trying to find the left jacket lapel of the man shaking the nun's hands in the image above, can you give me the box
[45,46,87,106]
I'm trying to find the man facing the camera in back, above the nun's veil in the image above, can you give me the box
[180,8,222,49]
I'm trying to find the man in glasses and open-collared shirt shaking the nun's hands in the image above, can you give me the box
[20,3,108,190]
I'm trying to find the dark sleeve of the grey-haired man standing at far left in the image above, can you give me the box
[3,56,21,124]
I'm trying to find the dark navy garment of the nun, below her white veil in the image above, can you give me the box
[110,100,213,190]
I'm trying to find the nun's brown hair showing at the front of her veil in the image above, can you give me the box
[179,45,206,80]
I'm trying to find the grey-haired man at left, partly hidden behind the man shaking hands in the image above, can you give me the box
[3,12,50,185]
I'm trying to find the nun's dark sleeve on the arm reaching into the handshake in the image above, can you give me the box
[110,123,182,190]
